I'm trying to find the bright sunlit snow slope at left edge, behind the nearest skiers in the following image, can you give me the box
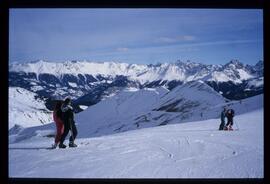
[8,87,53,129]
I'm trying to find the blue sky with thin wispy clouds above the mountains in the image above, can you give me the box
[9,9,263,65]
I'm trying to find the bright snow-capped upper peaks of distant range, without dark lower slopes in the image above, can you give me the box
[9,60,263,83]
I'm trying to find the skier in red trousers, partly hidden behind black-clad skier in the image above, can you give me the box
[52,101,64,149]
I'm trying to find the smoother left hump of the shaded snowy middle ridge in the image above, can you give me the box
[75,87,168,137]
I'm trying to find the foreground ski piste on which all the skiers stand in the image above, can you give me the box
[9,92,264,179]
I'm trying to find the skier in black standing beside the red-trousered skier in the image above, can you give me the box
[59,98,78,148]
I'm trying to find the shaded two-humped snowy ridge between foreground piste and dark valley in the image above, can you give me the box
[75,81,226,137]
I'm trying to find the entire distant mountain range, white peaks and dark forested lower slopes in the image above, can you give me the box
[9,60,264,111]
